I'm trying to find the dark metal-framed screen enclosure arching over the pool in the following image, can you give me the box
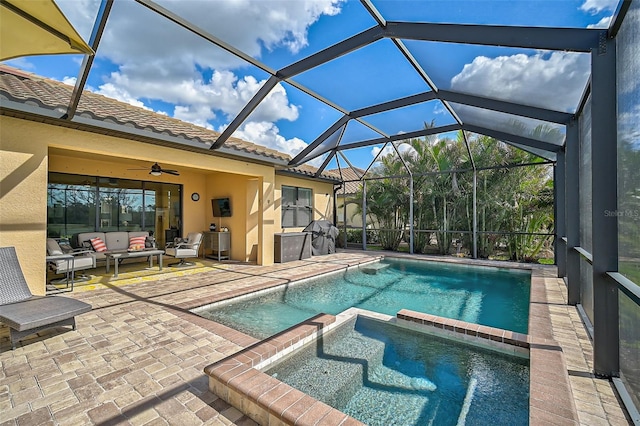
[2,0,640,416]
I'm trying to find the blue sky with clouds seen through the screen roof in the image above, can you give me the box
[7,0,618,168]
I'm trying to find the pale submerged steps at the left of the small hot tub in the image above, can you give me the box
[265,320,384,409]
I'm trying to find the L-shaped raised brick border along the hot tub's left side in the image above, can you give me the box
[204,314,363,426]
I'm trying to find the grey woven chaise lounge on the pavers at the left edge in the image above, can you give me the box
[0,247,91,349]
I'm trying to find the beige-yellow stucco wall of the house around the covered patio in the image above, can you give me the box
[0,116,332,294]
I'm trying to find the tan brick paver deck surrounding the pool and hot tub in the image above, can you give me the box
[0,252,629,425]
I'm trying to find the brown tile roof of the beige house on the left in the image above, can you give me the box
[0,64,335,179]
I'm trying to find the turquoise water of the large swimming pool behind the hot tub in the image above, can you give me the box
[194,259,531,339]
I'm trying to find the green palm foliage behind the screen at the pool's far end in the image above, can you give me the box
[348,129,553,261]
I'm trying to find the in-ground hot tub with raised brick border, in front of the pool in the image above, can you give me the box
[206,308,529,425]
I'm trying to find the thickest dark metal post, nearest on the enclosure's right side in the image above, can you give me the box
[591,32,620,377]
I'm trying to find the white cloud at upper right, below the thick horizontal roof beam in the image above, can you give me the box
[451,52,590,111]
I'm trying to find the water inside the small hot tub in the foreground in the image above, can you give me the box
[264,316,529,426]
